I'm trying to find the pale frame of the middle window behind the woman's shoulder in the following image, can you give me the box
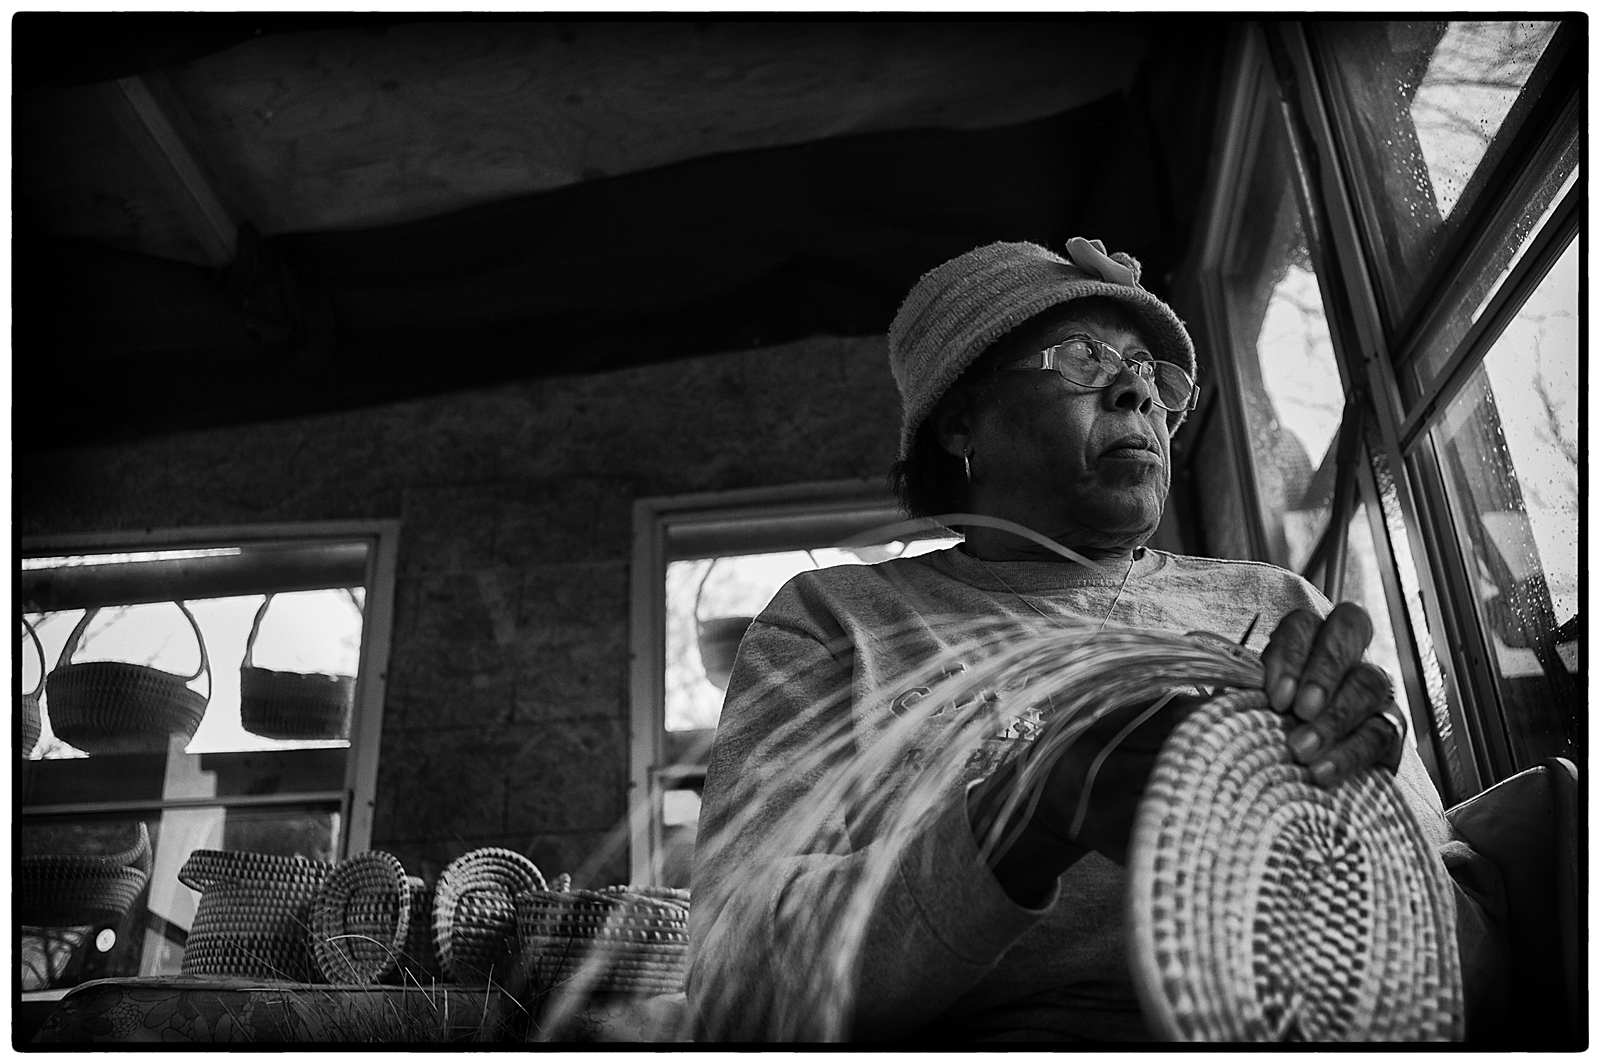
[627,480,904,885]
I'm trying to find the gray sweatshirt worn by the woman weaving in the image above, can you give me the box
[688,547,1497,1040]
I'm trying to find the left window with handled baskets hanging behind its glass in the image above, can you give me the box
[14,523,395,997]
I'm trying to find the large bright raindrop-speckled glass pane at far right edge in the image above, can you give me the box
[1430,242,1581,765]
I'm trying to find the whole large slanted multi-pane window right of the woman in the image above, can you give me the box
[1197,19,1584,800]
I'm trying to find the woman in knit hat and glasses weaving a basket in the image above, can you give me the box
[690,238,1496,1040]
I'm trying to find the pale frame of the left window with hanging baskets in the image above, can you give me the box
[14,520,400,858]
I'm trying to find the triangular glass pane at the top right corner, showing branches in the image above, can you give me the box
[1317,21,1558,322]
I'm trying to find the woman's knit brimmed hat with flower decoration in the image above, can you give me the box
[890,237,1195,459]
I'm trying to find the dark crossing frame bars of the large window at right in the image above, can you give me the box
[1195,21,1584,802]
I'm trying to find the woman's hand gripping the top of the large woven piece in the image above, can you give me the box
[1261,602,1406,787]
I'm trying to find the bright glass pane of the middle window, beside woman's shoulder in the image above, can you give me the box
[666,539,960,729]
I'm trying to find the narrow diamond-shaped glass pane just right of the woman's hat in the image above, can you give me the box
[1222,101,1344,571]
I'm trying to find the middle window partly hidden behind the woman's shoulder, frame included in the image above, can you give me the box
[630,482,958,886]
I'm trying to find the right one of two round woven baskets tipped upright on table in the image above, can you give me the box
[434,846,546,984]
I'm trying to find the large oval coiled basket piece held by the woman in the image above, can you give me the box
[1128,691,1462,1042]
